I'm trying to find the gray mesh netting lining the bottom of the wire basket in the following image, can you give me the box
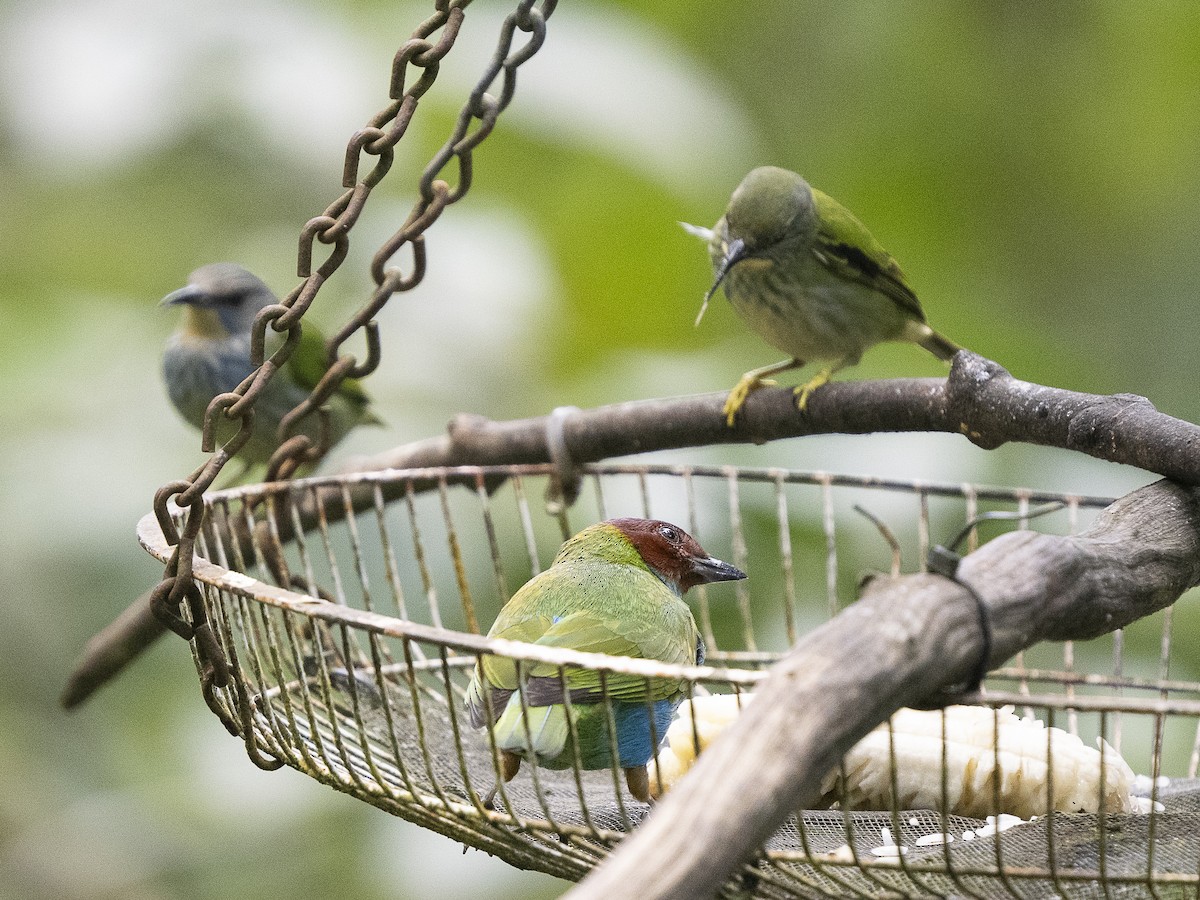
[260,678,1200,898]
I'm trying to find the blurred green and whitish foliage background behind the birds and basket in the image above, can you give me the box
[0,0,1200,899]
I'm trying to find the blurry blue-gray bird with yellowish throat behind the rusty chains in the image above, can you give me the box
[162,263,379,478]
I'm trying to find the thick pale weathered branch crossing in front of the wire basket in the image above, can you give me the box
[568,481,1200,900]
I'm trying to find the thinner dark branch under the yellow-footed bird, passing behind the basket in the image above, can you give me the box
[62,350,1200,707]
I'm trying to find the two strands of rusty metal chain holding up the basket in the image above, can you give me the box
[154,0,557,727]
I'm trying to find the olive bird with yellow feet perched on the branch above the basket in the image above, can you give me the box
[684,166,961,427]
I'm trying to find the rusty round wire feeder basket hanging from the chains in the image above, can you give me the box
[139,464,1200,898]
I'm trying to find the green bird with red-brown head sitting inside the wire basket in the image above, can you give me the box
[467,518,745,808]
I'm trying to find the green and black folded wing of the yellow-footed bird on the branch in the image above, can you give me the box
[812,188,925,322]
